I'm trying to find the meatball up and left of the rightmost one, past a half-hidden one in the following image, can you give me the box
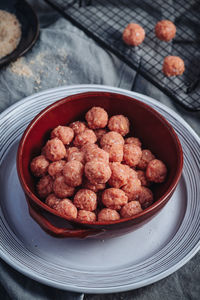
[123,144,142,167]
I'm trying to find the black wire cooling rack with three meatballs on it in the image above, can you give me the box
[45,0,200,111]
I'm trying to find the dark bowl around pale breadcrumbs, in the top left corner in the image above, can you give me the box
[0,0,39,67]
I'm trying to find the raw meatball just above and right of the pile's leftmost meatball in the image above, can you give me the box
[44,138,66,161]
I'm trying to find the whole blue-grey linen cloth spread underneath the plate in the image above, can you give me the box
[0,1,200,300]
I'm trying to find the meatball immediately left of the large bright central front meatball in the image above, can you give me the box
[63,160,84,187]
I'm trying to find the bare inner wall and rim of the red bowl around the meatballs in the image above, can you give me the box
[17,92,183,225]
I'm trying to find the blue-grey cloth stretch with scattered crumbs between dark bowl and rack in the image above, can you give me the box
[0,0,135,111]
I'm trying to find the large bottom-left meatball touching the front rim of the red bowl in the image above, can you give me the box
[54,199,77,219]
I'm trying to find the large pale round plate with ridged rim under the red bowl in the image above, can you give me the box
[0,85,200,293]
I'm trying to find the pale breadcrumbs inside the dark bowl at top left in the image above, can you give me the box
[0,10,21,59]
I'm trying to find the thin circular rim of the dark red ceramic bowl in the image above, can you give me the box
[17,90,183,228]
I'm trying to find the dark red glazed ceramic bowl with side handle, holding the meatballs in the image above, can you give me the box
[17,92,183,238]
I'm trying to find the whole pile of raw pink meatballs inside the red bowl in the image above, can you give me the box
[30,107,167,222]
